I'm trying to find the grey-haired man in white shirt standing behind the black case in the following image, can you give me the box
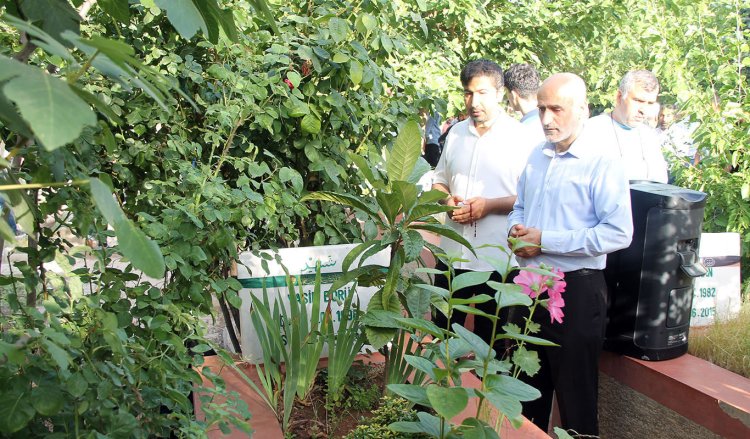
[586,70,667,183]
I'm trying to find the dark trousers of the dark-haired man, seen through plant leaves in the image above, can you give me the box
[433,262,517,358]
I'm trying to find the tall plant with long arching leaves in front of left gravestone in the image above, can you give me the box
[302,117,470,388]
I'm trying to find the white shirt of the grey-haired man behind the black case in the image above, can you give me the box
[586,113,667,183]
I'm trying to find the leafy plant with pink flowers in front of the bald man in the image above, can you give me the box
[388,254,564,438]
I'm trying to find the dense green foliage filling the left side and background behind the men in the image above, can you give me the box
[0,0,750,437]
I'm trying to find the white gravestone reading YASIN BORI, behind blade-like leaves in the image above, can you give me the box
[237,244,390,364]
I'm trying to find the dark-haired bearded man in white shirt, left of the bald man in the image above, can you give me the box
[432,60,533,350]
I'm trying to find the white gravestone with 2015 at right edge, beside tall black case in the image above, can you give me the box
[690,233,742,326]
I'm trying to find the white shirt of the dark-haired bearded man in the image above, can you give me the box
[433,114,534,271]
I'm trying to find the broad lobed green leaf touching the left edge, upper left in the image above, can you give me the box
[3,71,96,151]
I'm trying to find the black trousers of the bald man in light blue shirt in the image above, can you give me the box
[521,271,607,436]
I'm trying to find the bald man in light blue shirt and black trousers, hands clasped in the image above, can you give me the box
[508,73,633,436]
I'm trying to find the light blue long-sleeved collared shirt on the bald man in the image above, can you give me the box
[508,129,633,272]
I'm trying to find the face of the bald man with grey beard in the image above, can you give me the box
[537,87,584,148]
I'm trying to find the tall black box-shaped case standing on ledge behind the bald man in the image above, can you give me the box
[604,181,706,360]
